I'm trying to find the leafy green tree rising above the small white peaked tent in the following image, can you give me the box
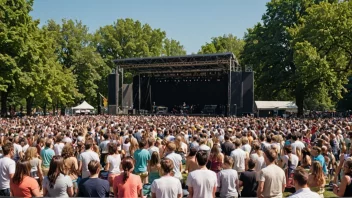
[45,20,108,108]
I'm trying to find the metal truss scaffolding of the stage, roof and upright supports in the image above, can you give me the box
[114,53,242,115]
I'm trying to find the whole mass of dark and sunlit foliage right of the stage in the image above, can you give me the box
[241,0,351,114]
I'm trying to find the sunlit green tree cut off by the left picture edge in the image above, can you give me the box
[0,0,36,115]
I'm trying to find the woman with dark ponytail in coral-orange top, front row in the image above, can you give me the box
[113,157,143,198]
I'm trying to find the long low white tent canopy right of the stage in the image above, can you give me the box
[255,101,298,110]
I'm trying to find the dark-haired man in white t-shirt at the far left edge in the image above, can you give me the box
[0,143,16,197]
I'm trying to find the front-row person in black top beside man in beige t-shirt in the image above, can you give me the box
[239,159,258,197]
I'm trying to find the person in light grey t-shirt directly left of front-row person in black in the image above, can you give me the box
[218,156,240,198]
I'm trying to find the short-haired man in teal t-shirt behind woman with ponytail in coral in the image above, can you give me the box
[133,140,150,184]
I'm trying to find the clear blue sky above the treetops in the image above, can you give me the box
[31,0,268,54]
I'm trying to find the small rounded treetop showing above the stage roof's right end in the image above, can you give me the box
[198,34,245,59]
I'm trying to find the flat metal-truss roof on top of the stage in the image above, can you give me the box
[114,52,239,73]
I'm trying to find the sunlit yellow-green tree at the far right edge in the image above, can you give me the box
[289,1,352,111]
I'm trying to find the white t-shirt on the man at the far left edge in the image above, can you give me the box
[0,157,16,189]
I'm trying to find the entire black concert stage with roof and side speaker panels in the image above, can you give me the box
[108,53,254,116]
